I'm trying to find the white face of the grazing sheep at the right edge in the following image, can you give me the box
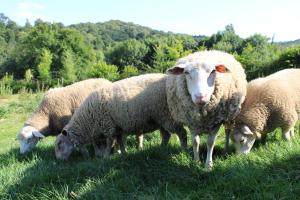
[231,125,256,154]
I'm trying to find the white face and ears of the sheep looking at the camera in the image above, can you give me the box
[167,60,228,104]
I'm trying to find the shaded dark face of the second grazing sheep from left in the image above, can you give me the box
[55,134,74,160]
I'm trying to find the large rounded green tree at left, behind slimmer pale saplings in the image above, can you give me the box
[10,20,95,81]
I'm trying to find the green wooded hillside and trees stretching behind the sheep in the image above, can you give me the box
[0,13,300,94]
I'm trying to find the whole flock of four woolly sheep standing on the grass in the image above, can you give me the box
[17,51,300,170]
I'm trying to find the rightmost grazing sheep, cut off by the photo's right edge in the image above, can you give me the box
[231,69,300,154]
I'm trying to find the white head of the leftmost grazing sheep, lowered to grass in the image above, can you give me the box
[17,126,45,154]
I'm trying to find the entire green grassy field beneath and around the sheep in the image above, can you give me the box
[0,94,300,200]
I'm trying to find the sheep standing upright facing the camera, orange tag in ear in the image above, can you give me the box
[166,51,247,170]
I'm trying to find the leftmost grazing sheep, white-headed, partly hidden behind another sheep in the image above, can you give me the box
[17,79,111,154]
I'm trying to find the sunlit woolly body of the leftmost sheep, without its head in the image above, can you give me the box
[25,79,110,136]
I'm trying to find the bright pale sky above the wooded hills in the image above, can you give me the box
[0,0,300,41]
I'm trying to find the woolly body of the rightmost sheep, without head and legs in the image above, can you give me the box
[236,69,300,134]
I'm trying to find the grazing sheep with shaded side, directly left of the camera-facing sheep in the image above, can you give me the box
[55,74,187,160]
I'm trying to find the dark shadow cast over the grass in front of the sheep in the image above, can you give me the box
[1,139,300,199]
